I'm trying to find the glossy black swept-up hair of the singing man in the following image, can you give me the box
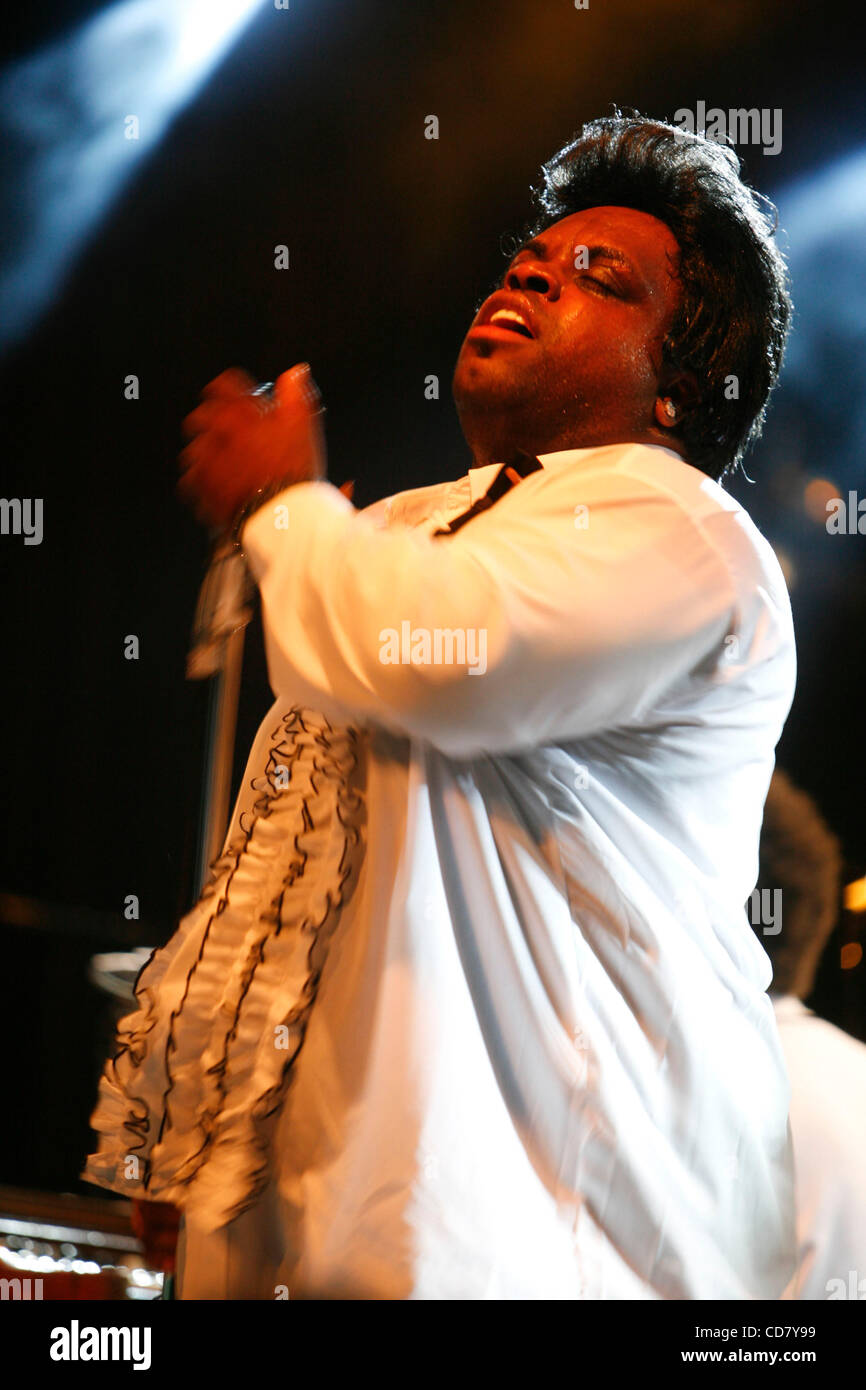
[523,111,792,482]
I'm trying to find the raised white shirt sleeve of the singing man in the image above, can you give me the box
[242,455,737,758]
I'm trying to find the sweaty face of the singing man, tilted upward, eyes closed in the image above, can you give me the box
[453,207,681,457]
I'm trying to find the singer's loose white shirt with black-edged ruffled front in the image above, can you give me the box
[83,445,795,1300]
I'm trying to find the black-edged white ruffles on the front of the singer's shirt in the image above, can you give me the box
[81,706,366,1229]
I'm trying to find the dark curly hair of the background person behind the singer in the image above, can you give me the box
[755,767,842,999]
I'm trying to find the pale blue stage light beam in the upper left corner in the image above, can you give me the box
[0,0,263,346]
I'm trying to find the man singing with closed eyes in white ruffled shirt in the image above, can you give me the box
[83,115,795,1300]
